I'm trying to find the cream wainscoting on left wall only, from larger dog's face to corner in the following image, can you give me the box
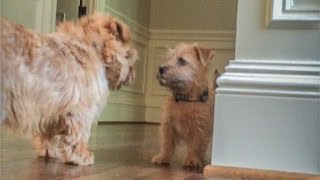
[98,1,149,122]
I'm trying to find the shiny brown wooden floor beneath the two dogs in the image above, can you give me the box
[0,124,212,180]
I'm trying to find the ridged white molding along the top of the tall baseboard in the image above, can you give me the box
[216,60,320,98]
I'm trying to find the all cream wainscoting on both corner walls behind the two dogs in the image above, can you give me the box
[97,0,235,122]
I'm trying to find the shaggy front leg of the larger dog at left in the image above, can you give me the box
[48,114,94,165]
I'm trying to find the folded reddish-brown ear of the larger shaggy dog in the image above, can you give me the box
[105,18,131,43]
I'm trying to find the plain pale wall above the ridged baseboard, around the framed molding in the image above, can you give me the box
[236,0,320,61]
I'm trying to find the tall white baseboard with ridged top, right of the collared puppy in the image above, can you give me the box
[212,60,320,174]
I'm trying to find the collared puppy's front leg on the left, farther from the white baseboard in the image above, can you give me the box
[152,121,175,164]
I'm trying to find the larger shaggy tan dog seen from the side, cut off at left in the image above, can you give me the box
[0,14,137,165]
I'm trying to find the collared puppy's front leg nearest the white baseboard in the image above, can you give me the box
[183,135,209,167]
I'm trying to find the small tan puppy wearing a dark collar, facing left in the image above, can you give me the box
[152,44,215,167]
